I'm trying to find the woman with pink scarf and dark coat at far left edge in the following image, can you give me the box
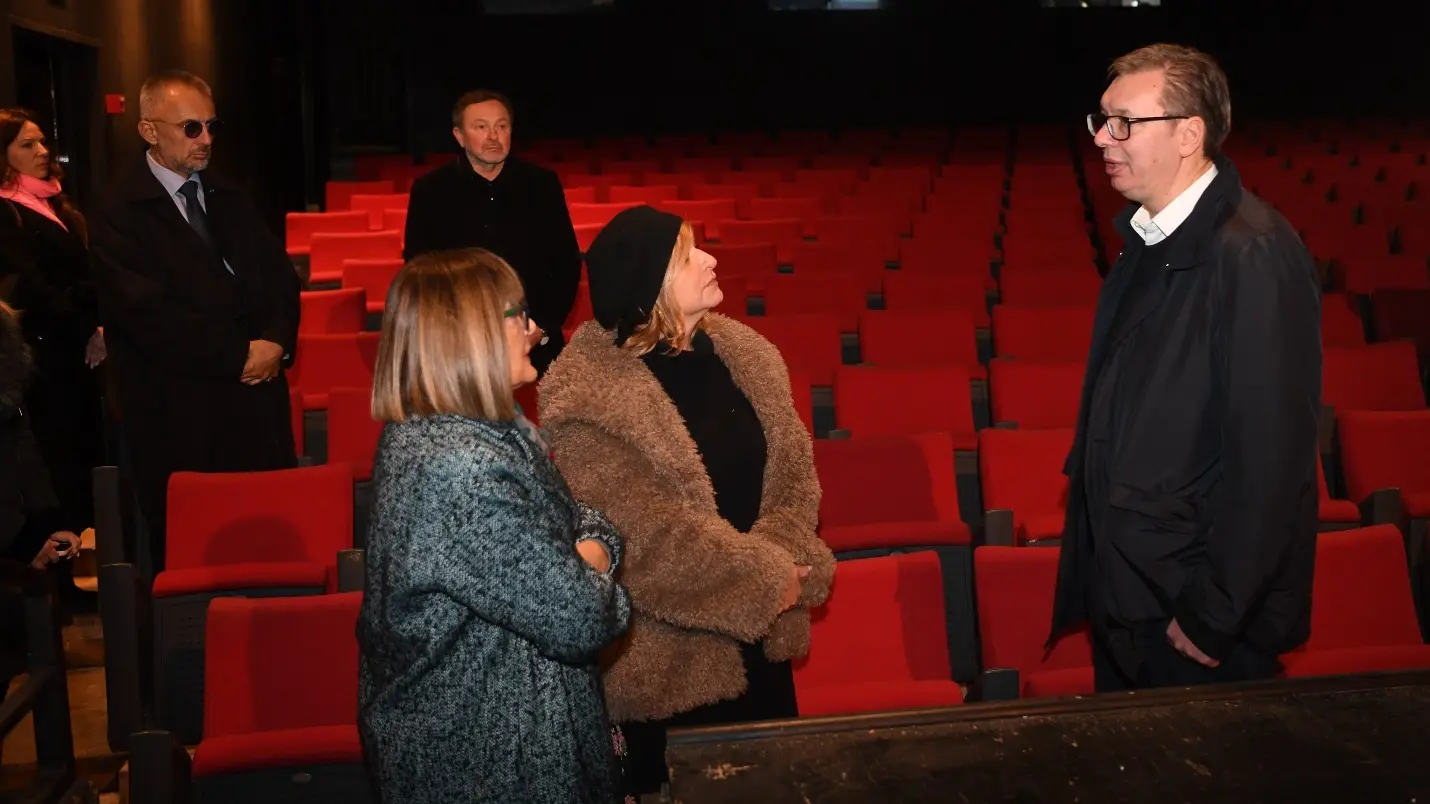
[0,109,104,611]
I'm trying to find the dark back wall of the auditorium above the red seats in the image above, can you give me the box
[322,0,1430,160]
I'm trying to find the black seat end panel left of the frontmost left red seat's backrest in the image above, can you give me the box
[99,564,152,749]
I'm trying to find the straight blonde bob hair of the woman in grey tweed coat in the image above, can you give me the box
[372,249,523,422]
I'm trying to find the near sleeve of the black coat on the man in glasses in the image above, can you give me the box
[1174,233,1321,660]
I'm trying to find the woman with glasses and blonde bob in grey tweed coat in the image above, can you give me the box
[358,250,631,804]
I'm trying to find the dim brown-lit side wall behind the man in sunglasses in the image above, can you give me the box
[0,0,306,232]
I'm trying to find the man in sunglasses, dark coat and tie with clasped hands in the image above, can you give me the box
[90,72,299,572]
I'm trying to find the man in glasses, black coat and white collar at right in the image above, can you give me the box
[1052,44,1321,691]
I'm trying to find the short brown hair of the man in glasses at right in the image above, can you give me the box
[1107,44,1231,159]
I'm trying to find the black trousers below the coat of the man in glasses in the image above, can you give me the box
[1093,619,1280,692]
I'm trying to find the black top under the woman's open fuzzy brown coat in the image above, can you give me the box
[644,332,765,532]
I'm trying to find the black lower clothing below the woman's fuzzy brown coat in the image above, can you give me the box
[621,644,799,798]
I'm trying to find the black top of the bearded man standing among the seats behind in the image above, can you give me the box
[402,156,581,338]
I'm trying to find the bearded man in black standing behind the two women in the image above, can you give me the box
[402,90,581,372]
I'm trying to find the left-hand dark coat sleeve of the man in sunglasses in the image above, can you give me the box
[90,203,250,382]
